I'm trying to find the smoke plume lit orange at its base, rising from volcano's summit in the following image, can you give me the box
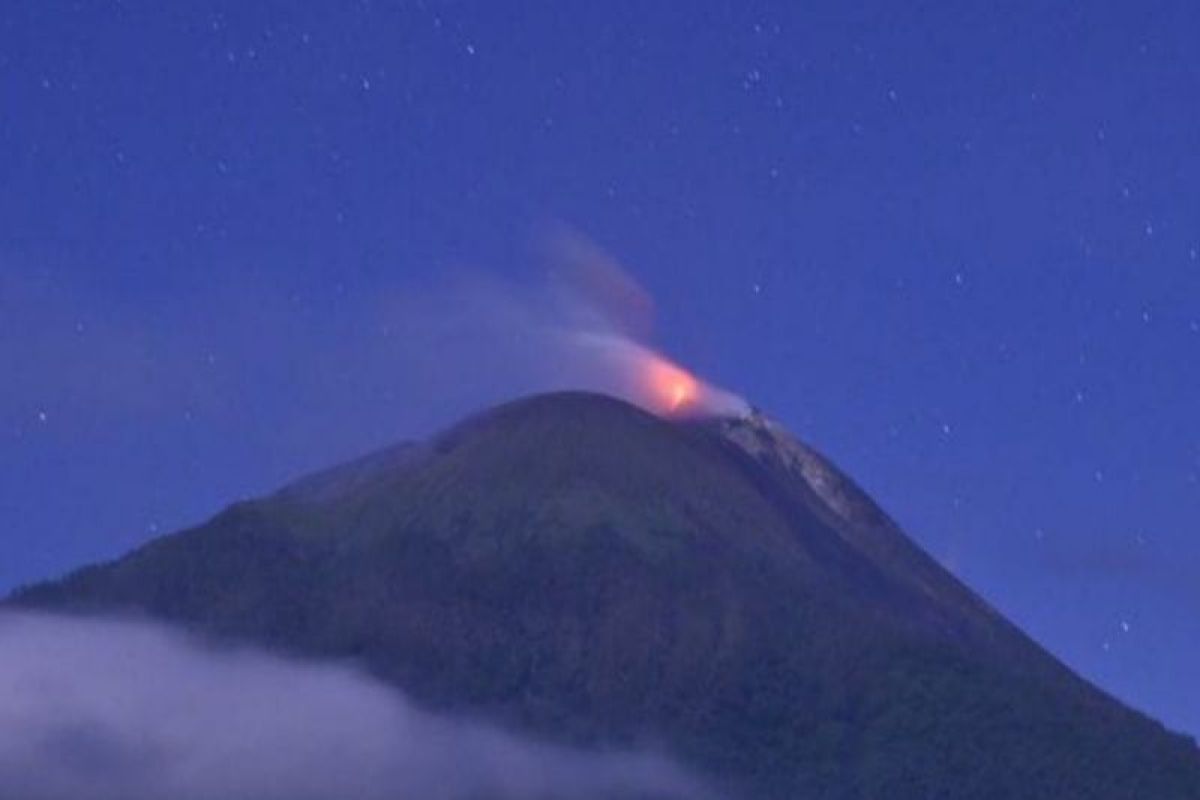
[396,227,749,416]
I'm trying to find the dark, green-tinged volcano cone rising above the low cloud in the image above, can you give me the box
[11,392,1200,800]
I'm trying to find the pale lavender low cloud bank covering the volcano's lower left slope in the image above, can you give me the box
[0,612,708,800]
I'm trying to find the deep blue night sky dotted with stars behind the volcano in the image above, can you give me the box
[0,0,1200,735]
